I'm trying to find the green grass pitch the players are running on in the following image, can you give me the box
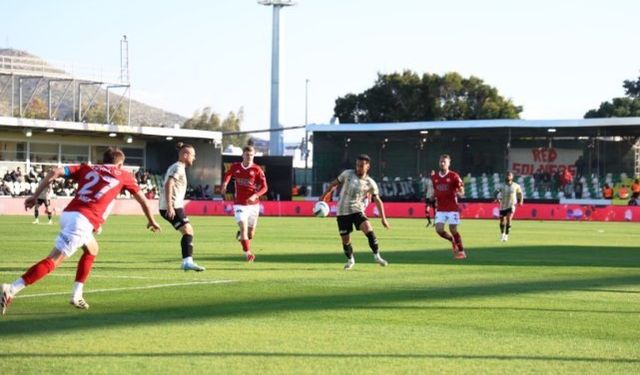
[0,216,640,374]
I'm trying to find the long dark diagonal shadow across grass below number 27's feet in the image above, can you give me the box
[0,274,640,337]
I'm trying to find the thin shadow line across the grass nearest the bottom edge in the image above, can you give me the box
[0,352,640,364]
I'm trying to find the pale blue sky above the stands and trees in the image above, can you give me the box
[0,0,640,141]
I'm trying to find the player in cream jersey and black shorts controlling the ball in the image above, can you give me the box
[320,154,389,270]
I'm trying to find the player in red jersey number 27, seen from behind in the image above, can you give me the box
[0,148,160,315]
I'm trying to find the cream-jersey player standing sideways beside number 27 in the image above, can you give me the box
[158,142,205,272]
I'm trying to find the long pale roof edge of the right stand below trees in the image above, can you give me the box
[306,117,640,132]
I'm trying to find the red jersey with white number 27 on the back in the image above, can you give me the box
[64,164,140,230]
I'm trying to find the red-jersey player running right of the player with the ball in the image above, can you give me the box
[431,154,467,259]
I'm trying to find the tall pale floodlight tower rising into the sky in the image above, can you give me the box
[258,0,296,155]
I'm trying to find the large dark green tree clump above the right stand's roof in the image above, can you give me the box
[334,70,522,123]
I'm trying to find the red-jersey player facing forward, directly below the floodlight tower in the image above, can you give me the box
[220,146,268,262]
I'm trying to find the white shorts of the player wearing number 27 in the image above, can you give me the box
[56,211,93,257]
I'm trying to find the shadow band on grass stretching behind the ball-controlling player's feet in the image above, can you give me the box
[202,245,640,268]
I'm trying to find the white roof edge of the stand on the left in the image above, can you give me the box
[0,116,222,143]
